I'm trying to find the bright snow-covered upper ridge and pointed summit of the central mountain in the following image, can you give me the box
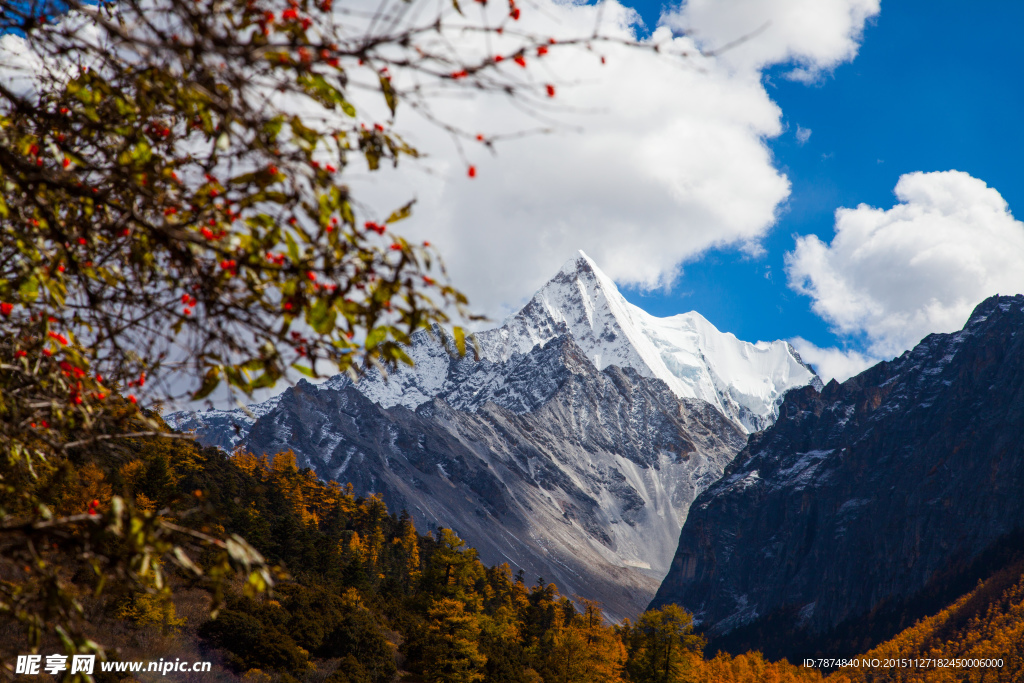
[328,251,820,433]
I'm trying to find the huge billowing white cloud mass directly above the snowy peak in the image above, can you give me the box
[348,0,877,317]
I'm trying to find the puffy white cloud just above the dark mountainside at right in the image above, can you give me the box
[786,171,1024,357]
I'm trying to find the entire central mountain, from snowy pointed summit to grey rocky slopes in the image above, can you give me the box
[167,253,820,618]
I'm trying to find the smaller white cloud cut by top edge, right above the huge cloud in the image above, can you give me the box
[663,0,881,81]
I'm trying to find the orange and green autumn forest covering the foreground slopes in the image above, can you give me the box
[0,421,1024,683]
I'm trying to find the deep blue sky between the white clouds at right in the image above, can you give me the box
[624,0,1024,370]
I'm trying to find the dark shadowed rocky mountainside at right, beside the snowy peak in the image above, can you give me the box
[652,296,1024,635]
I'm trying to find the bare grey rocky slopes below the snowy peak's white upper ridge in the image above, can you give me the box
[244,336,745,618]
